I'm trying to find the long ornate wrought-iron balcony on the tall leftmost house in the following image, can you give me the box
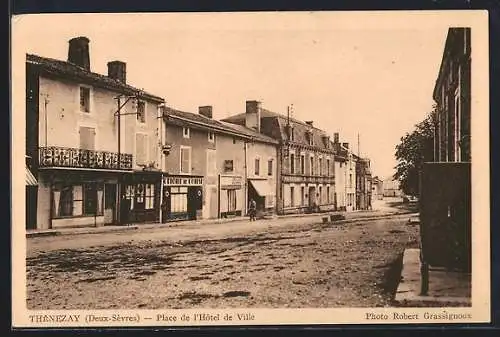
[39,146,132,170]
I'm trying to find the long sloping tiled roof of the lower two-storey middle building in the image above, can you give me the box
[163,106,277,143]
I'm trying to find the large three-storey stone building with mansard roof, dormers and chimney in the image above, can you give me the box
[223,101,335,214]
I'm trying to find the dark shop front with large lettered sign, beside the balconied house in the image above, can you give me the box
[162,175,203,223]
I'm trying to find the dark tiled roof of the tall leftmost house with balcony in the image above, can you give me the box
[26,54,165,103]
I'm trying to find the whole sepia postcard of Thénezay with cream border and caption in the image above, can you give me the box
[11,10,491,328]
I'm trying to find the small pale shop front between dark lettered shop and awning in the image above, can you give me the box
[219,175,244,218]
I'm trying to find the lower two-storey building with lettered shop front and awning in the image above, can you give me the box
[162,106,277,221]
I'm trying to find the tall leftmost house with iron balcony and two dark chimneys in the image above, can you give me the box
[26,37,163,229]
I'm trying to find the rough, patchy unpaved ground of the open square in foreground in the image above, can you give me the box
[26,216,418,309]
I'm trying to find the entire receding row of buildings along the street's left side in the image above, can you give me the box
[26,37,372,229]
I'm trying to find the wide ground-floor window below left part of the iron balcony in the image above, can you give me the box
[52,183,104,218]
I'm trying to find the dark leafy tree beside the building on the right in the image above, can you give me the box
[393,107,436,196]
